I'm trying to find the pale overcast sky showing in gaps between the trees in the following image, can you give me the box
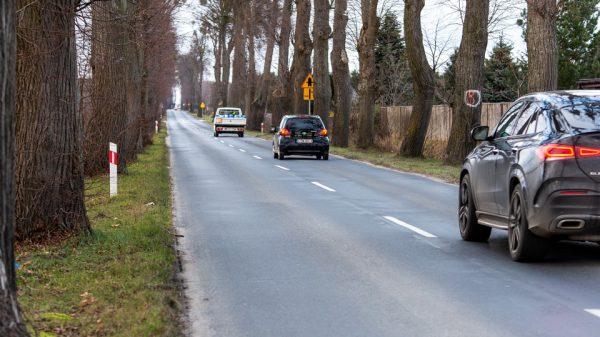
[175,0,526,80]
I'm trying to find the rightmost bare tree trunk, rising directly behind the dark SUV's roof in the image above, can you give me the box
[527,0,558,92]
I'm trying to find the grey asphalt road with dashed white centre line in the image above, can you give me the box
[168,111,600,337]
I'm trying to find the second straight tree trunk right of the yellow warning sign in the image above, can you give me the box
[331,0,352,147]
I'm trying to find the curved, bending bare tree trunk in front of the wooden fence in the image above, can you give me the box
[400,0,435,157]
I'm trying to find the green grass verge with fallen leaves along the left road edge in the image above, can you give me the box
[17,128,181,336]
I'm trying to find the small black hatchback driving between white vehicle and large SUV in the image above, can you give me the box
[273,115,329,160]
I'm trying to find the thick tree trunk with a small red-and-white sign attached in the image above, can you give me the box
[445,0,490,164]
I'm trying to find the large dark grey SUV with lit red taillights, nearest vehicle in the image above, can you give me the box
[458,90,600,261]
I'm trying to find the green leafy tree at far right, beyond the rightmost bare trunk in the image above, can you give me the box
[556,0,600,89]
